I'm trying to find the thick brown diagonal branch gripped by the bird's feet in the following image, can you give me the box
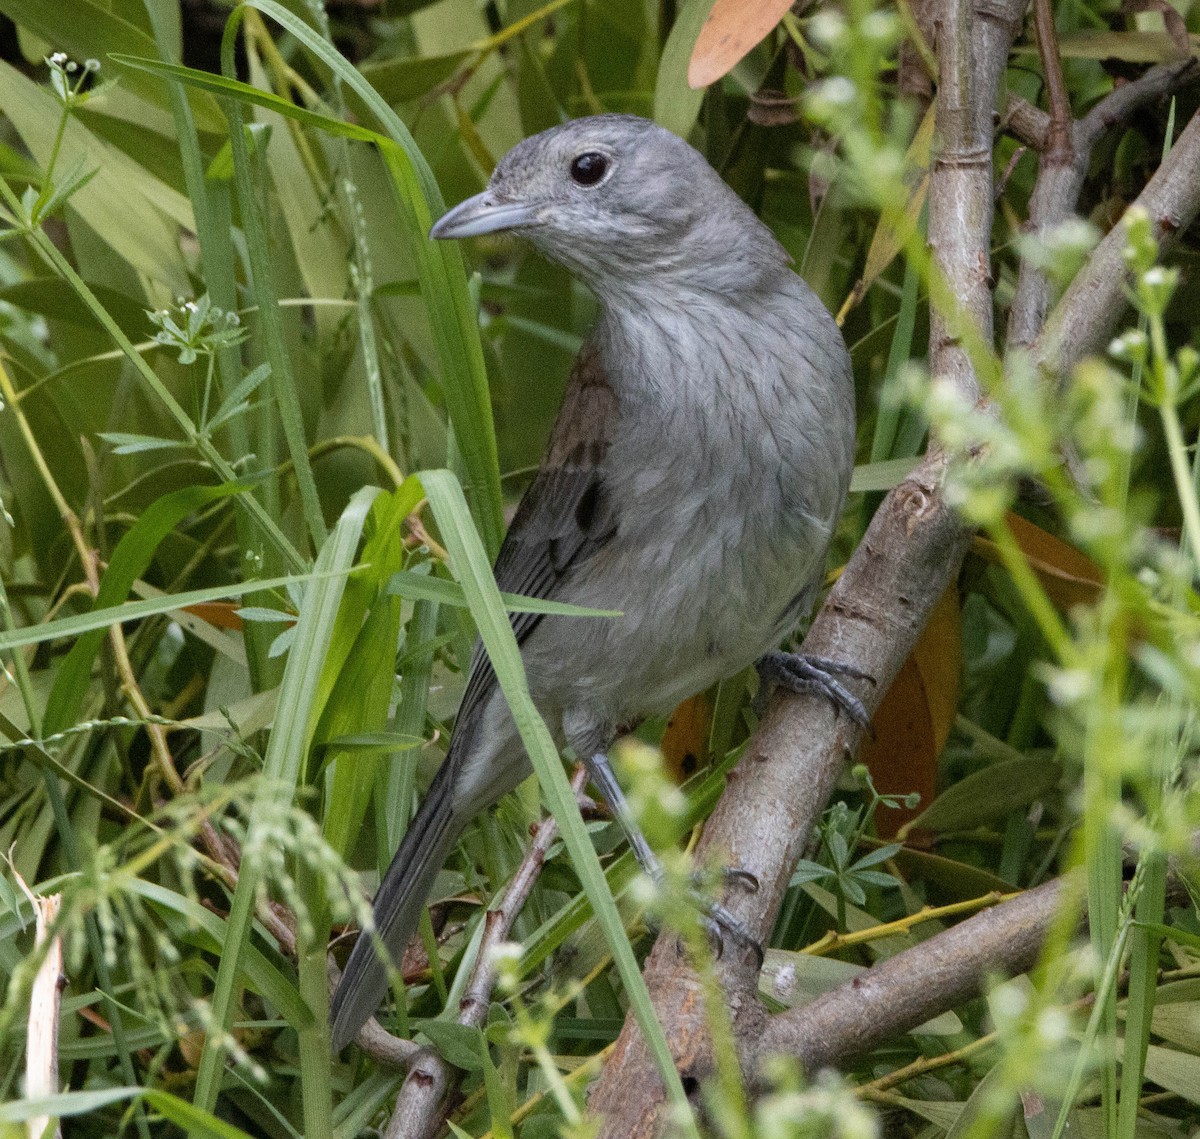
[589,461,968,1139]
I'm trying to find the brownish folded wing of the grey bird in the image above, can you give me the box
[458,344,617,723]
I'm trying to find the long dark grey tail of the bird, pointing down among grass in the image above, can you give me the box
[330,756,464,1051]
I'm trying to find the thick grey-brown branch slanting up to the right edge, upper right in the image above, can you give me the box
[1032,100,1200,374]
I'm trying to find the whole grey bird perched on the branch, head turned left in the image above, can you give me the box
[332,115,865,1049]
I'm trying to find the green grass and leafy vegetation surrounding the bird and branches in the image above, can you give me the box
[0,0,1200,1139]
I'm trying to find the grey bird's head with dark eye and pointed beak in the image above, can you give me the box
[430,115,788,300]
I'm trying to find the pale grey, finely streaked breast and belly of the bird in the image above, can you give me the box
[527,292,853,720]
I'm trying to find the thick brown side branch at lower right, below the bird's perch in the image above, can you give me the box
[757,880,1064,1072]
